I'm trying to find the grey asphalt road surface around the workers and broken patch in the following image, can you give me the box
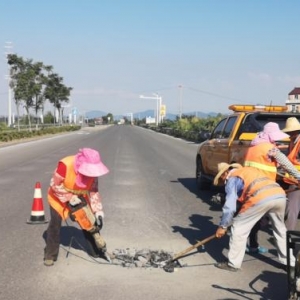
[0,125,287,300]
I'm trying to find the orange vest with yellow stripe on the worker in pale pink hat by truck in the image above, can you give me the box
[244,142,277,181]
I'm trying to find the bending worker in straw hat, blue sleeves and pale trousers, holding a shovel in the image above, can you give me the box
[214,163,295,272]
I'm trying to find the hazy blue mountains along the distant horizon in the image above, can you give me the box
[85,109,218,121]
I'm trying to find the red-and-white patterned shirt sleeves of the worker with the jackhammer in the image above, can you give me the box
[50,162,104,217]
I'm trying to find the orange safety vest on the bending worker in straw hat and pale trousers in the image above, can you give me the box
[229,167,286,213]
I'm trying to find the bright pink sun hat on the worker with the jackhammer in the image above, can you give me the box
[75,148,109,177]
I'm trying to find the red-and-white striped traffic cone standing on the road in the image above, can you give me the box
[27,182,48,224]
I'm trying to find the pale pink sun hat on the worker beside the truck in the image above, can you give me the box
[251,122,289,146]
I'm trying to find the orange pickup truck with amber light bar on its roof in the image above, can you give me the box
[196,104,300,190]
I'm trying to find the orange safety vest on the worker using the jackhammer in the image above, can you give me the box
[48,155,94,220]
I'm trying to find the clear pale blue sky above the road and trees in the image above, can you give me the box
[0,0,300,115]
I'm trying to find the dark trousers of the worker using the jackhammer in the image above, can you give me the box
[44,206,102,261]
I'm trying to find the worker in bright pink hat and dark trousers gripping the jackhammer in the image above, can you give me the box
[44,148,109,266]
